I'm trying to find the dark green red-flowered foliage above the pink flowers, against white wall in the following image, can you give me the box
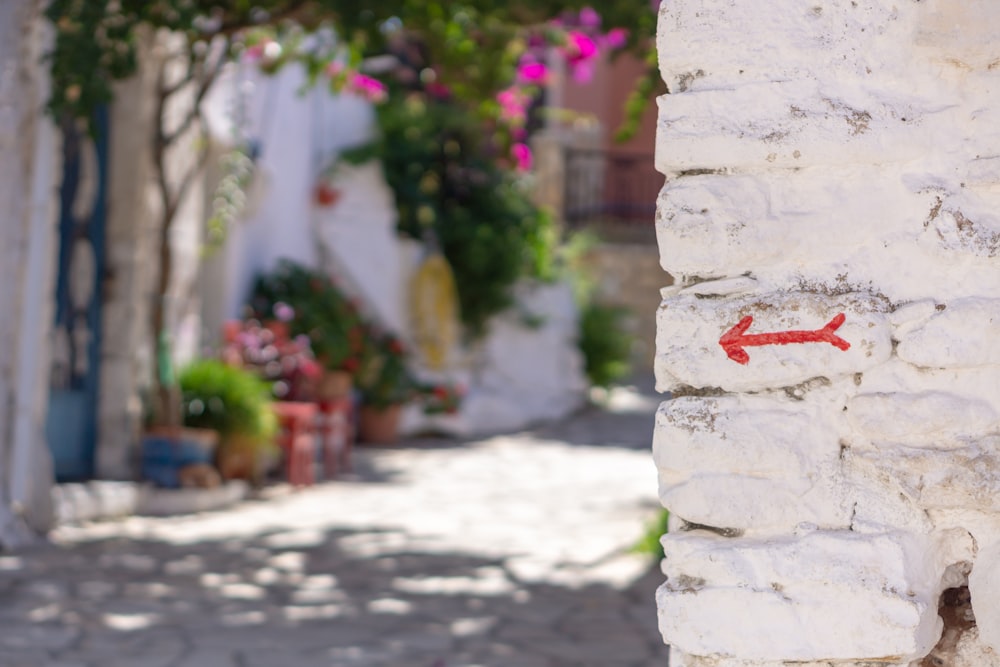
[250,260,370,373]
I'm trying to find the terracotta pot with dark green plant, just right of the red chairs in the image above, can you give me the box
[357,335,417,444]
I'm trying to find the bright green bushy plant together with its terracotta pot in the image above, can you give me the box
[179,359,278,482]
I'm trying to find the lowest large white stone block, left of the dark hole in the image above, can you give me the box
[657,531,941,664]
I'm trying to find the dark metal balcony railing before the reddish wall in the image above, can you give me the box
[563,148,663,233]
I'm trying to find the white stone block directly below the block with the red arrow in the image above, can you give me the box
[653,396,851,532]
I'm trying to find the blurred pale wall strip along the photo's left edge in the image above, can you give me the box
[0,0,59,548]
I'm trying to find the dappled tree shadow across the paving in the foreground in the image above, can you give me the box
[0,530,666,667]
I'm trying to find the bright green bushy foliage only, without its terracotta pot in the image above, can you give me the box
[180,359,277,445]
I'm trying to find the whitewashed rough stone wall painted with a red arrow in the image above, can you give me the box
[654,0,1000,667]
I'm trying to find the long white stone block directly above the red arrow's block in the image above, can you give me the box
[656,166,938,286]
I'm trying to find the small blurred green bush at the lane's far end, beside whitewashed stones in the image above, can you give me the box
[578,302,632,387]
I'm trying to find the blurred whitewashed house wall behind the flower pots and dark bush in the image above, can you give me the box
[201,66,587,435]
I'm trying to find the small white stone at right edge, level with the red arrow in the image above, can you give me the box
[896,297,1000,368]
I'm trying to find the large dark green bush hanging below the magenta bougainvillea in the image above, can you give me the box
[364,95,558,338]
